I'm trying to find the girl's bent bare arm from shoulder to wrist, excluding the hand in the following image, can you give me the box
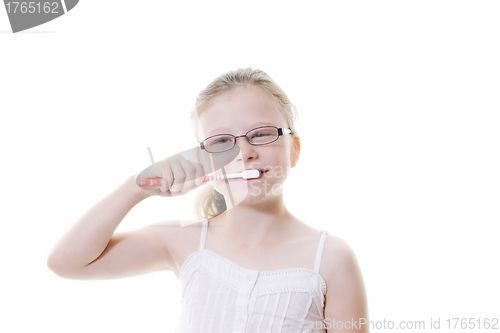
[47,176,176,279]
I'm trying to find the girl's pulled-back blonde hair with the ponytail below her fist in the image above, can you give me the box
[190,68,300,219]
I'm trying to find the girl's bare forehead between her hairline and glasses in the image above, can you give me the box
[200,85,285,137]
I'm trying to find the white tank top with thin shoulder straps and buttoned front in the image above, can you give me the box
[177,219,328,333]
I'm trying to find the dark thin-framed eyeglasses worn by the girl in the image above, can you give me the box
[200,126,292,153]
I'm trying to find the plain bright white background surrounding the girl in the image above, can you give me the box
[0,0,500,332]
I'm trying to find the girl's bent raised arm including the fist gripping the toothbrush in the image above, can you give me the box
[47,154,207,279]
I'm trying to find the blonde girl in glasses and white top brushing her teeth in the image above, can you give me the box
[48,68,368,333]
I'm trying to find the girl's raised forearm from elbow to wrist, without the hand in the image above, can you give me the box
[47,176,147,271]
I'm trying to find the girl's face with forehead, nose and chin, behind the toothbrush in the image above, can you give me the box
[198,85,293,209]
